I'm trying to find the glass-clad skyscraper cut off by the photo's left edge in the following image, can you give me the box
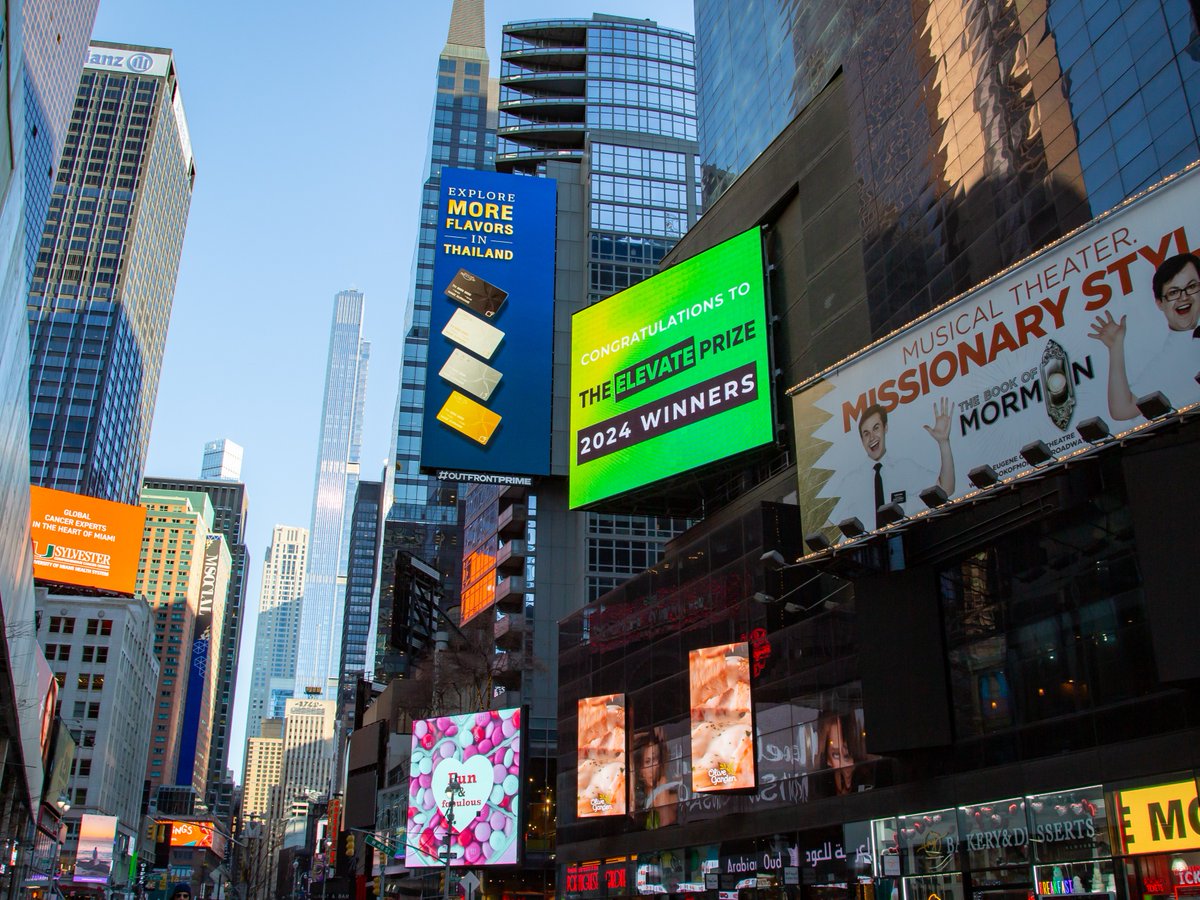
[0,0,96,838]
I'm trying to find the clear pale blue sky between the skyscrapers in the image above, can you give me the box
[95,0,692,780]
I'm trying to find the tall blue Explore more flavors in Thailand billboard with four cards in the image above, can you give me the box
[421,168,557,478]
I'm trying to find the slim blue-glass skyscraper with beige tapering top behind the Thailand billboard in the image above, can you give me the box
[379,0,496,672]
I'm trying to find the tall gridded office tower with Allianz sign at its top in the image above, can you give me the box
[28,43,196,503]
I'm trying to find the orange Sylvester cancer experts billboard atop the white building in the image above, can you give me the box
[30,486,146,594]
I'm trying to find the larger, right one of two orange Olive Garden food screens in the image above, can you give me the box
[688,641,756,792]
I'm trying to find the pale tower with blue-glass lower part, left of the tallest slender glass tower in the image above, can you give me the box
[246,524,308,738]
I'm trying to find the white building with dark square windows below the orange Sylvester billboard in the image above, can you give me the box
[37,588,158,871]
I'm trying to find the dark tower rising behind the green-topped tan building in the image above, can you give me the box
[143,476,250,821]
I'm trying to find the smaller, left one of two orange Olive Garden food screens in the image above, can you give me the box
[576,694,629,818]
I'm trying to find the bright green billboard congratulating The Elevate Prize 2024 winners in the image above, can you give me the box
[569,228,774,509]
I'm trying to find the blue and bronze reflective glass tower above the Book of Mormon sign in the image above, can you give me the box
[696,0,1200,336]
